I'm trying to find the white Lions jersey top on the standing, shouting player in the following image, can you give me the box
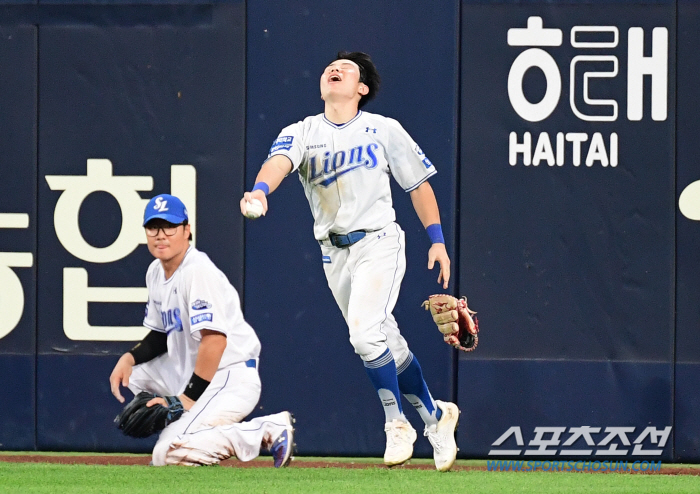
[268,111,436,240]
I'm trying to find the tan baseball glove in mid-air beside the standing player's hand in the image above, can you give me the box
[422,294,479,352]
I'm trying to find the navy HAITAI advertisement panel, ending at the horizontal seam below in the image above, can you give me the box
[460,2,676,361]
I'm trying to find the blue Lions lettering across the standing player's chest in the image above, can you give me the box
[307,142,379,187]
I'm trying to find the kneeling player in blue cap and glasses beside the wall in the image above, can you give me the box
[109,194,294,467]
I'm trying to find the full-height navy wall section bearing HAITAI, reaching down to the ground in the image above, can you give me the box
[459,2,676,460]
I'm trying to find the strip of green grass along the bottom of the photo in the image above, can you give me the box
[0,459,700,494]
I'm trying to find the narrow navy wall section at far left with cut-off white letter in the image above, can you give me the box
[0,26,37,449]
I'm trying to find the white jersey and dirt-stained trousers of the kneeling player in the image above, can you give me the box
[129,247,287,465]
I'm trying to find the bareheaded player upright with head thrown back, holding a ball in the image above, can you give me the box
[241,52,459,471]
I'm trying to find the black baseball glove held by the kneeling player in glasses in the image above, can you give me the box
[114,391,185,437]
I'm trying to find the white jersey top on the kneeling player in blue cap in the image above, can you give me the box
[143,246,260,387]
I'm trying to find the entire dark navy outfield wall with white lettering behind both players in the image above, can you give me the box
[0,0,700,461]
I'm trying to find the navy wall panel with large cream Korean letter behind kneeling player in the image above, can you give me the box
[37,3,245,449]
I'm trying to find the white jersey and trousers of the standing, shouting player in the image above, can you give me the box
[269,111,436,366]
